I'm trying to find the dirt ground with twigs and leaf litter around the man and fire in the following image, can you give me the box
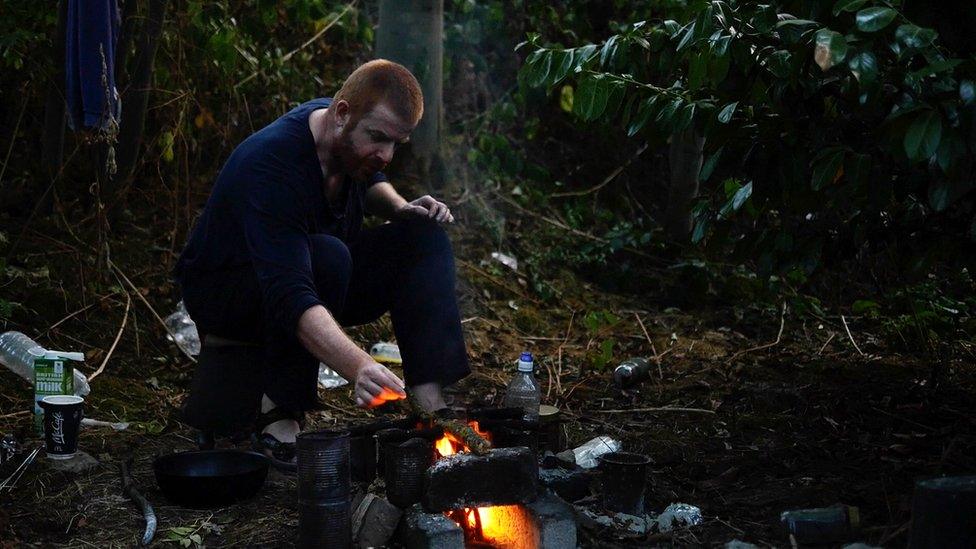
[0,209,976,547]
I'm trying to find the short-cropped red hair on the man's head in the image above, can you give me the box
[333,59,424,125]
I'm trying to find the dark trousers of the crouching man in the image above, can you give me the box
[182,221,470,428]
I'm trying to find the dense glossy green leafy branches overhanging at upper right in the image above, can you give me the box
[522,0,976,283]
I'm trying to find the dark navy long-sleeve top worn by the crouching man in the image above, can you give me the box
[175,98,386,330]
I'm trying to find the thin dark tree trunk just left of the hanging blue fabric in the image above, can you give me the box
[39,0,68,211]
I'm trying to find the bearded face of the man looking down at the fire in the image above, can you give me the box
[336,104,415,179]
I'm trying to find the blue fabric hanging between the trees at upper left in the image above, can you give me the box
[64,0,120,130]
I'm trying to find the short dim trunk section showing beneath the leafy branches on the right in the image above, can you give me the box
[664,129,705,242]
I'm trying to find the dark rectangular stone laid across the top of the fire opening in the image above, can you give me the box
[422,447,539,512]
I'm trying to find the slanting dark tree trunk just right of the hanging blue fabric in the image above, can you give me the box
[114,0,168,206]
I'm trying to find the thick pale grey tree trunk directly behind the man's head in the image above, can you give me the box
[376,0,445,189]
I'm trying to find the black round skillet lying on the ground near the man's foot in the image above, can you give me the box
[153,450,269,507]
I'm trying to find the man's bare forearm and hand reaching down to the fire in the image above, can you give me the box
[298,305,404,406]
